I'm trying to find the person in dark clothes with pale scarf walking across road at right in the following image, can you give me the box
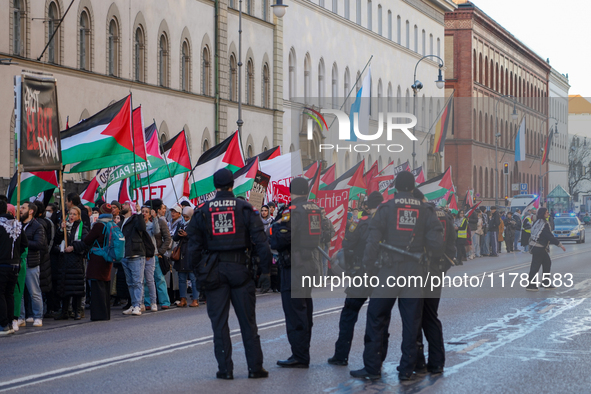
[526,208,566,291]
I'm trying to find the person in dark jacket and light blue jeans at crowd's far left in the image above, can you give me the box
[18,202,47,327]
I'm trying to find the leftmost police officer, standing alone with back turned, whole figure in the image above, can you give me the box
[186,169,271,379]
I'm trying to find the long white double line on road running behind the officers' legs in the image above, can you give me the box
[0,306,343,393]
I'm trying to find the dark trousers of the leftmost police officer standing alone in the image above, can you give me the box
[205,261,263,372]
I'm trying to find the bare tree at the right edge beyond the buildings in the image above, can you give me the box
[568,136,591,199]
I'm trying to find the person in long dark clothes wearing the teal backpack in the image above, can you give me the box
[83,204,113,321]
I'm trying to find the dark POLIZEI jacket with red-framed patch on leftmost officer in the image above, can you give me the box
[186,191,272,274]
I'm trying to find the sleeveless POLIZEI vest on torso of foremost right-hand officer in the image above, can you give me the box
[376,192,427,253]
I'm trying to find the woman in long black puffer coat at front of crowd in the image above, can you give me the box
[54,206,88,320]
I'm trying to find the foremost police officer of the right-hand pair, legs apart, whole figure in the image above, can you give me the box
[351,171,443,380]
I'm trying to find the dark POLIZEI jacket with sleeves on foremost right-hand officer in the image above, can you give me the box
[363,192,443,267]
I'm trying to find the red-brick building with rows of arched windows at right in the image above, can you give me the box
[445,3,550,205]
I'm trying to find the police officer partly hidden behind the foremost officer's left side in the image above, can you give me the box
[328,191,388,365]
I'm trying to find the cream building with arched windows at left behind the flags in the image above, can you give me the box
[0,0,283,185]
